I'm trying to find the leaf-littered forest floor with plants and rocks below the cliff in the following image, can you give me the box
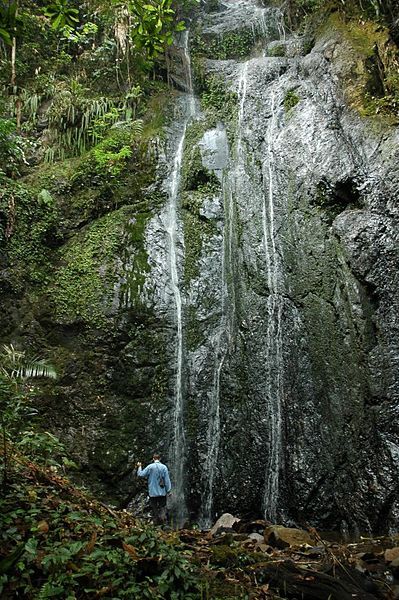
[0,453,399,600]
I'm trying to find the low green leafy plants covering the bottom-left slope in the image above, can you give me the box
[0,455,199,600]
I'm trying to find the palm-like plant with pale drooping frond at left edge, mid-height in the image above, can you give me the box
[0,344,57,488]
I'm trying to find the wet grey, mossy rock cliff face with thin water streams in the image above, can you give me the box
[1,0,399,530]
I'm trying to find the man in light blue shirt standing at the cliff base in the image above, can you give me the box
[137,453,172,525]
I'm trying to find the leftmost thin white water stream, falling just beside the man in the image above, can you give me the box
[165,31,196,526]
